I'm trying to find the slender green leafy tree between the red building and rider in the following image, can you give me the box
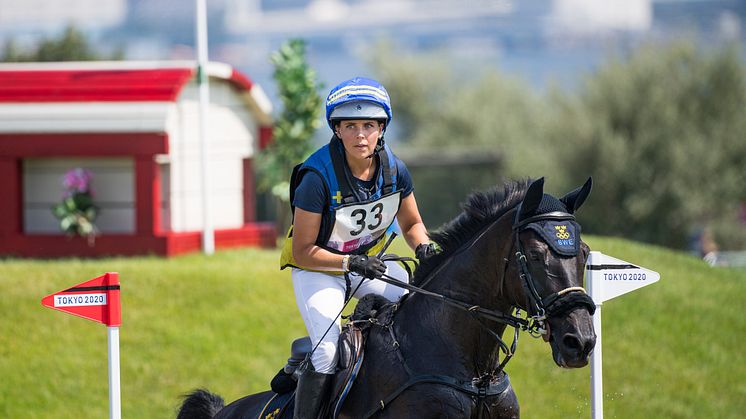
[257,39,322,228]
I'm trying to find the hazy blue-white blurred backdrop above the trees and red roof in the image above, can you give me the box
[0,0,746,97]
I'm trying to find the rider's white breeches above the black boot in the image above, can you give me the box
[292,262,407,374]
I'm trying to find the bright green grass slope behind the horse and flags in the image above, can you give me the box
[0,237,746,419]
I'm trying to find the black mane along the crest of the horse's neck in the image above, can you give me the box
[413,179,531,284]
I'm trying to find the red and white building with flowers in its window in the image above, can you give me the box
[0,62,276,257]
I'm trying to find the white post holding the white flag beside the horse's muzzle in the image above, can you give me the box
[585,252,604,419]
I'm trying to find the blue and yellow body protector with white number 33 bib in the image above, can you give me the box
[280,136,401,269]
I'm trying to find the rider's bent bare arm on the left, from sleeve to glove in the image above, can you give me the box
[293,207,344,271]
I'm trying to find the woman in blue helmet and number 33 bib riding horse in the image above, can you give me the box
[282,77,434,418]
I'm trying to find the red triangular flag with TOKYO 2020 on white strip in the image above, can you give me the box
[41,272,122,326]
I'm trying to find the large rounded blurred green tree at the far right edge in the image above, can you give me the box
[548,42,746,248]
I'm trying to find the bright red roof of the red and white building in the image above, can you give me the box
[0,63,252,103]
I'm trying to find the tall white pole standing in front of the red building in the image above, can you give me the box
[196,0,215,255]
